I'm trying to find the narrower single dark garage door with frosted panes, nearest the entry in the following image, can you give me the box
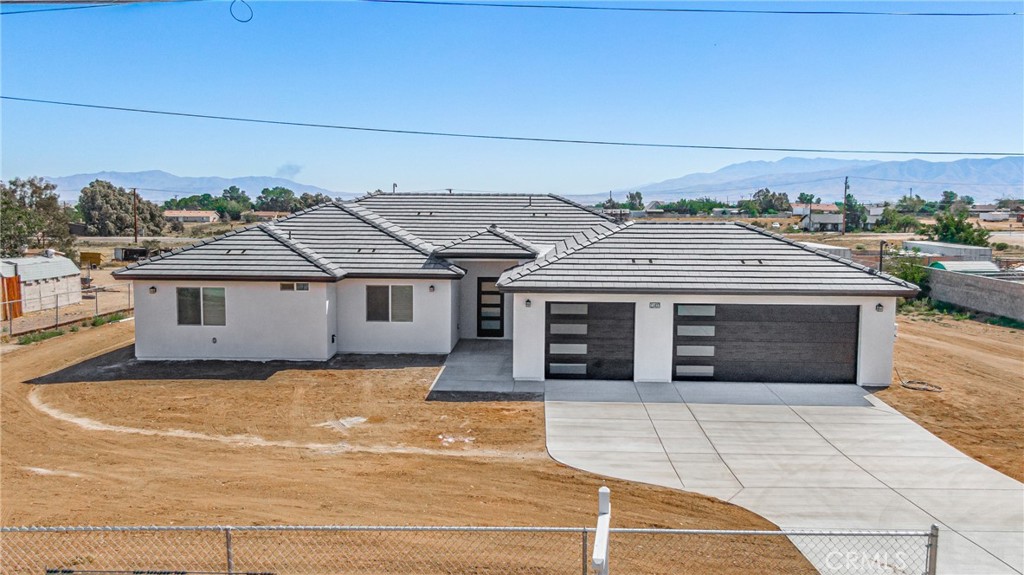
[544,302,634,380]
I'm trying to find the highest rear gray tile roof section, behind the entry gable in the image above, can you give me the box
[355,193,613,246]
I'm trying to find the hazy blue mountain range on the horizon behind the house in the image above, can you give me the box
[46,158,1024,205]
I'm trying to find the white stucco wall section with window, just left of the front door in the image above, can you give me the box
[335,278,458,353]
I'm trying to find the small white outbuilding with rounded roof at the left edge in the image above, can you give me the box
[0,250,82,318]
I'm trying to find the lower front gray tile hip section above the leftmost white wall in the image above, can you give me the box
[114,224,344,281]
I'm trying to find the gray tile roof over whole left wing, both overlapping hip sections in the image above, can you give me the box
[114,204,465,281]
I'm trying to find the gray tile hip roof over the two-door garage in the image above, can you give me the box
[498,222,918,296]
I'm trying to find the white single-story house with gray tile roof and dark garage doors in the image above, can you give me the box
[115,193,918,386]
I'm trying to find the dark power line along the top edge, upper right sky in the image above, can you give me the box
[359,0,1021,16]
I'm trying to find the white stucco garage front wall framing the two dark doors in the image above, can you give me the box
[512,294,896,386]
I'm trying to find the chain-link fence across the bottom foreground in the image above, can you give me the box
[0,527,935,575]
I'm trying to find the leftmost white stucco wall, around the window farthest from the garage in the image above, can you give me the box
[133,280,335,360]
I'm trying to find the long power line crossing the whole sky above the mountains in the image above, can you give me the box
[0,96,1024,156]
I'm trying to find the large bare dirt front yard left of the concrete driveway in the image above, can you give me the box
[2,322,790,536]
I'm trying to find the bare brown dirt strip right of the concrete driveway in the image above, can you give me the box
[878,316,1024,481]
